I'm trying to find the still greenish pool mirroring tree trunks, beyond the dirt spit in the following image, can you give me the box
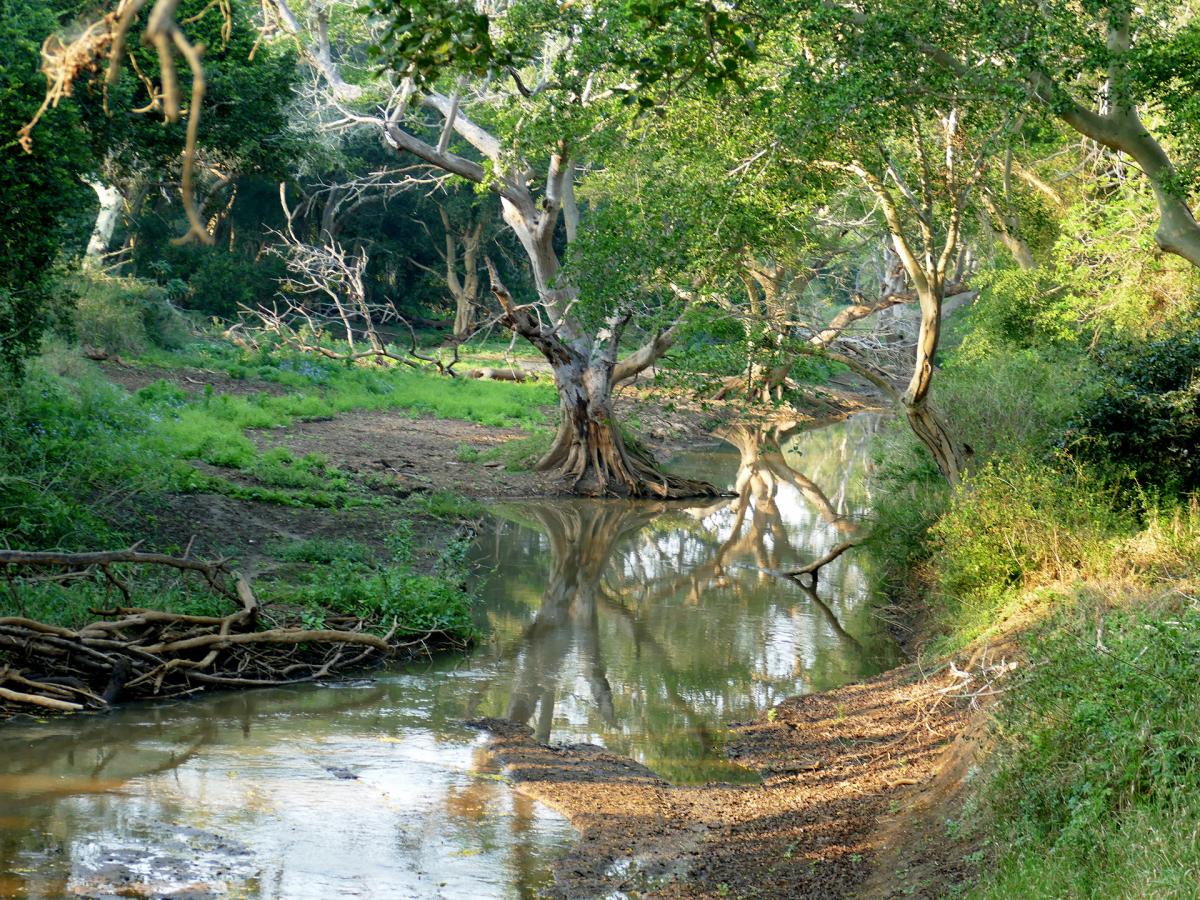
[473,416,894,781]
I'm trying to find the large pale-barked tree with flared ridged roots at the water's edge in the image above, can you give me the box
[284,0,744,497]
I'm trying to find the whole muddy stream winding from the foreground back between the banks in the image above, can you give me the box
[0,416,895,898]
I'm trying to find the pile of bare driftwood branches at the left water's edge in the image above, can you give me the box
[0,550,449,718]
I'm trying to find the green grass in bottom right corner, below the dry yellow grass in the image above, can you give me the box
[974,595,1200,898]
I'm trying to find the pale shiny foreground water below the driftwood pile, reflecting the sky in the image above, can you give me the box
[0,674,570,898]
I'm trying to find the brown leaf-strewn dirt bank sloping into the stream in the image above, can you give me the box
[478,652,979,898]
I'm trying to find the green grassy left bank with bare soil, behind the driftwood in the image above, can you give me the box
[0,328,554,691]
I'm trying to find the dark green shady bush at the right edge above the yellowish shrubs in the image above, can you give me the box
[1066,329,1200,494]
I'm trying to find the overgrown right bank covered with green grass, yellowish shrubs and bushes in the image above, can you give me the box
[871,308,1200,898]
